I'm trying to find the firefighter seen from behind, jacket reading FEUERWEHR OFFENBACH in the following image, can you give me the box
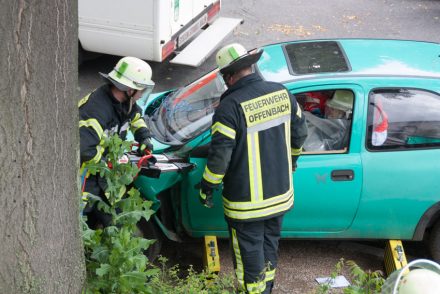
[200,44,307,293]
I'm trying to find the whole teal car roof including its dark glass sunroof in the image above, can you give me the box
[257,39,440,83]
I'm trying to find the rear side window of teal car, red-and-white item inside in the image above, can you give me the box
[366,89,440,150]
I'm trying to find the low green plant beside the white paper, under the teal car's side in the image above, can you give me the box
[316,258,385,294]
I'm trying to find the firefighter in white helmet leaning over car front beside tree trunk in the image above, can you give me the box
[78,57,154,227]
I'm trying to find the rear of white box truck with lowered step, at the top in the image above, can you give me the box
[78,0,242,66]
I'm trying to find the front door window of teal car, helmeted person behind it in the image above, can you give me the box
[295,89,354,154]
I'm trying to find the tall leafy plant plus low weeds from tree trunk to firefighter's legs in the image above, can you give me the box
[82,136,234,294]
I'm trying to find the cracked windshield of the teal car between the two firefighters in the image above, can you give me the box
[150,70,226,145]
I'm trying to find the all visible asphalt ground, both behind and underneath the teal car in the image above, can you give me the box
[77,0,440,293]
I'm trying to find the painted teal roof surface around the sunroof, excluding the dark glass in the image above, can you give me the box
[258,39,440,83]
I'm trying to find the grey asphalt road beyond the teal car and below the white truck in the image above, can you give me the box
[78,0,440,97]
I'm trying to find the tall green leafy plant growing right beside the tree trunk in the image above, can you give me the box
[82,136,159,293]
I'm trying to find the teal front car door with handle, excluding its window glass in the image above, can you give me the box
[283,83,364,236]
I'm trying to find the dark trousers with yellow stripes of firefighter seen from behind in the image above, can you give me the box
[226,215,283,293]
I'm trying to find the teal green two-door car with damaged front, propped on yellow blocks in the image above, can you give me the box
[135,39,440,261]
